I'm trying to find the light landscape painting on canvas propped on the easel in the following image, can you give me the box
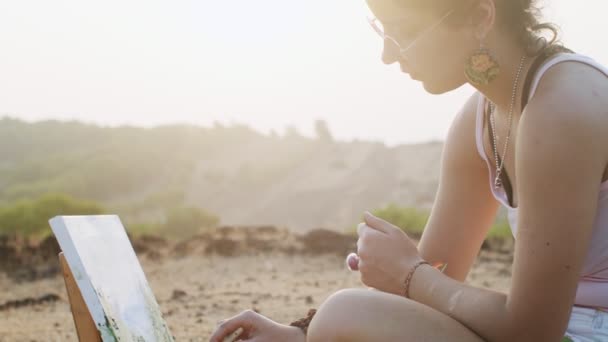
[49,215,173,342]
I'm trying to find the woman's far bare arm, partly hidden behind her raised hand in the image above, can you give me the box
[418,94,498,281]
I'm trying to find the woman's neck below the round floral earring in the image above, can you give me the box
[473,40,533,115]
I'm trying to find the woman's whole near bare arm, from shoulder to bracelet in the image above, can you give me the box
[410,63,608,341]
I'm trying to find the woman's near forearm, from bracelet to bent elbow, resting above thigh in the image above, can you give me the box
[410,265,511,341]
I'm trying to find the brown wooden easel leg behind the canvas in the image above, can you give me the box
[59,252,101,342]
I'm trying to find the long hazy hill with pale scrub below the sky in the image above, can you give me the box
[0,118,442,231]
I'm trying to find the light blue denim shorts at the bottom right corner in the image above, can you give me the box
[563,306,608,342]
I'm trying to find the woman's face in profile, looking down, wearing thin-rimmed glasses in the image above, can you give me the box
[367,0,479,94]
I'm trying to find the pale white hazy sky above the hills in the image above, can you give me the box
[0,0,608,145]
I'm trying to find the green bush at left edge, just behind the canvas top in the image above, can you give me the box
[0,194,104,237]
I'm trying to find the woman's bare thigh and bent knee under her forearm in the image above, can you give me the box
[307,289,483,342]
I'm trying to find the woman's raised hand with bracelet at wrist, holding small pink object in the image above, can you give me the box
[346,212,422,295]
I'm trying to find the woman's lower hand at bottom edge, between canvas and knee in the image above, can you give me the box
[209,310,306,342]
